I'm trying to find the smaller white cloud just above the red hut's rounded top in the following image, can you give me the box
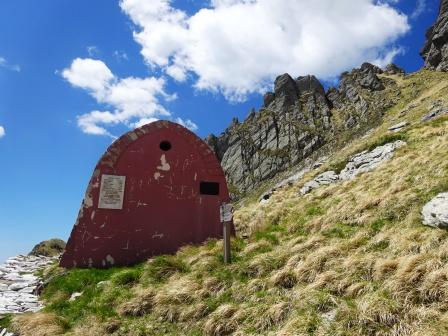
[62,58,176,137]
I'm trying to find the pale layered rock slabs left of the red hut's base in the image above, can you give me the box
[0,255,58,316]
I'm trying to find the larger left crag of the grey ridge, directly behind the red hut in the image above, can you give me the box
[207,74,331,191]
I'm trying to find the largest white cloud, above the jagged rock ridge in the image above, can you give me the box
[120,0,409,100]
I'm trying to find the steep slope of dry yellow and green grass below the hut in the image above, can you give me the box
[8,71,448,336]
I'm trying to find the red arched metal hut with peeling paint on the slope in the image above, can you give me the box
[60,121,234,268]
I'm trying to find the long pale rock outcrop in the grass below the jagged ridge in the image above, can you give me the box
[300,140,406,195]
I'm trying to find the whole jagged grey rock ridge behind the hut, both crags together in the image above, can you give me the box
[206,63,395,192]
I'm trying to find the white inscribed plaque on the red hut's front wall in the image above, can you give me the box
[98,174,126,210]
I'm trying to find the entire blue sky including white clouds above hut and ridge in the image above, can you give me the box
[0,0,439,261]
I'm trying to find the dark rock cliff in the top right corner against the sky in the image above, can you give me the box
[420,0,448,71]
